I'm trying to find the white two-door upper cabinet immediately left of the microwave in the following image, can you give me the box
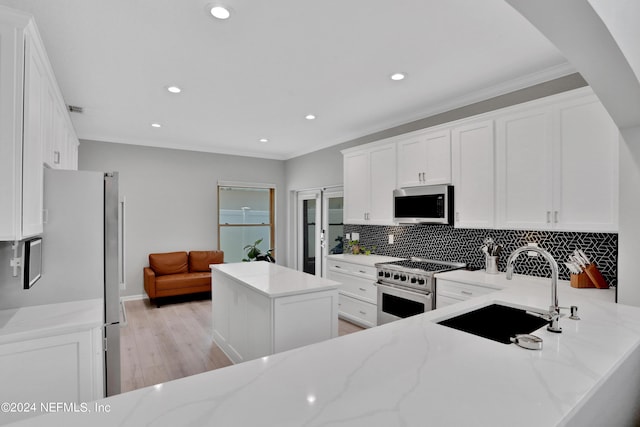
[343,143,396,225]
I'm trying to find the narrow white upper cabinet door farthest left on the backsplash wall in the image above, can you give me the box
[344,152,369,224]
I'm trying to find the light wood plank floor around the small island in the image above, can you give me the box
[120,299,362,392]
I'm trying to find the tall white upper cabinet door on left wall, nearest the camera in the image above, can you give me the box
[22,37,48,237]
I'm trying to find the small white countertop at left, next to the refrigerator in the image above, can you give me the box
[0,299,104,344]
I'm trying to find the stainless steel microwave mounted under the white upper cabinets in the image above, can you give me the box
[393,185,453,224]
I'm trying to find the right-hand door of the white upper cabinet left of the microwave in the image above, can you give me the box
[367,144,396,225]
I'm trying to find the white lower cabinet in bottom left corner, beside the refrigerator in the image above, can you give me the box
[0,328,104,424]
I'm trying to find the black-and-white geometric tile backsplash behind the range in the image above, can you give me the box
[344,224,618,286]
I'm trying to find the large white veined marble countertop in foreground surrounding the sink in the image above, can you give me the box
[8,272,640,427]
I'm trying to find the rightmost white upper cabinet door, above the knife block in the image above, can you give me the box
[553,97,619,231]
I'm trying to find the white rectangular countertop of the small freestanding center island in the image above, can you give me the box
[210,261,340,298]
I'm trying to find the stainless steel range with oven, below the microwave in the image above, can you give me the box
[376,258,466,325]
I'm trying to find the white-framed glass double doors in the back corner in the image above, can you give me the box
[296,188,344,277]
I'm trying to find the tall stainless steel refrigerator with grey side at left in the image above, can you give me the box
[39,169,123,396]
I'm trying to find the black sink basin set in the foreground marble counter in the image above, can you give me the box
[438,304,548,344]
